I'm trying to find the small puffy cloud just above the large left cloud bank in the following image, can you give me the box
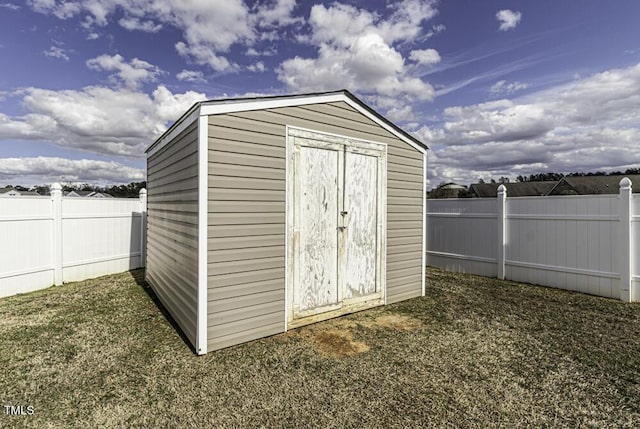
[86,54,163,88]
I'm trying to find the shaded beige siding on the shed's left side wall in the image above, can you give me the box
[146,119,198,347]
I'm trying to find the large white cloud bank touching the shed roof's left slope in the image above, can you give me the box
[0,86,206,157]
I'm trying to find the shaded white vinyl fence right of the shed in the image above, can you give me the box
[427,178,640,301]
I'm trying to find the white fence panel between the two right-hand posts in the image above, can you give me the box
[505,195,620,298]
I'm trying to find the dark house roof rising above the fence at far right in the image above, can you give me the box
[544,174,640,195]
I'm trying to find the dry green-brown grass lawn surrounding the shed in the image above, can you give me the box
[0,270,640,428]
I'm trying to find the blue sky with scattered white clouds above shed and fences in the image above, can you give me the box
[0,0,640,186]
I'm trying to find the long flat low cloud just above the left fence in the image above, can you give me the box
[0,156,145,184]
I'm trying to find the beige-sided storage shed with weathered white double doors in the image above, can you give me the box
[146,91,428,354]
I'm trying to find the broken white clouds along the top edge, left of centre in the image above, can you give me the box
[28,0,304,72]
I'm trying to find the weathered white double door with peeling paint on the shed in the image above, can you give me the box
[289,129,386,319]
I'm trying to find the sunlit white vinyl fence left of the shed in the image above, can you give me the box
[0,184,147,297]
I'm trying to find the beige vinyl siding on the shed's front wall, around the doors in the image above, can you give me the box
[208,102,423,350]
